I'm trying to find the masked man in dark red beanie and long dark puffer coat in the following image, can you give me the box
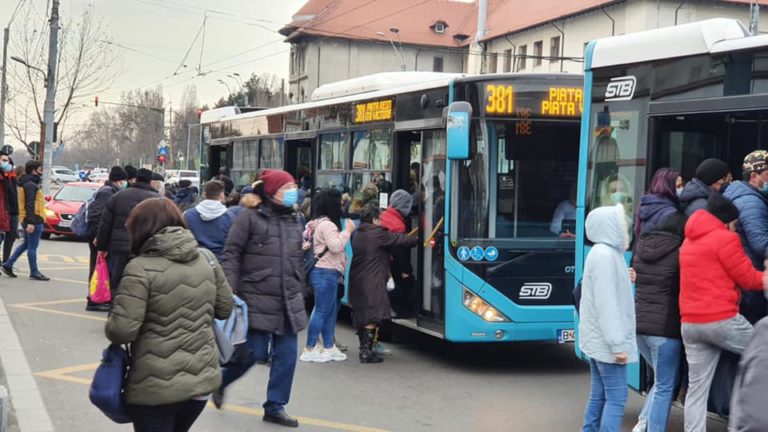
[213,169,307,427]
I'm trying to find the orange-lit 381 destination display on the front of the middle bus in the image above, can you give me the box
[484,84,584,117]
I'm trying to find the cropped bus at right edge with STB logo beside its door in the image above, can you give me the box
[576,19,768,404]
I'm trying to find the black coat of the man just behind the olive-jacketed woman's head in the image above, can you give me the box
[96,182,160,255]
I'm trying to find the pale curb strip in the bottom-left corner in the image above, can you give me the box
[0,299,55,432]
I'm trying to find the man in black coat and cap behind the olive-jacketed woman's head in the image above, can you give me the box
[96,168,160,290]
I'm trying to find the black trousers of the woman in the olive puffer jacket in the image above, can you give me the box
[126,400,207,432]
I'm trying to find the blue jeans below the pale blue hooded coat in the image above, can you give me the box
[581,359,627,432]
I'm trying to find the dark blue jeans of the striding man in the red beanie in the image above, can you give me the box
[221,330,298,414]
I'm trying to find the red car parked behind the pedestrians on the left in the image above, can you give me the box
[43,182,103,239]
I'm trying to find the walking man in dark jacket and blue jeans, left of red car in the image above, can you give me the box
[0,161,50,281]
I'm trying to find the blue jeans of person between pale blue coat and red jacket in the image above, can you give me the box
[637,335,683,432]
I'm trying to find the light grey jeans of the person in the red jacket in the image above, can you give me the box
[682,315,754,432]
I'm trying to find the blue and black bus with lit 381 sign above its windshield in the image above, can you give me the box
[201,72,583,342]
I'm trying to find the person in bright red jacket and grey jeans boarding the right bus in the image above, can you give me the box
[680,194,764,432]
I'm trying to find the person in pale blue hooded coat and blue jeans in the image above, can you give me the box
[579,204,637,432]
